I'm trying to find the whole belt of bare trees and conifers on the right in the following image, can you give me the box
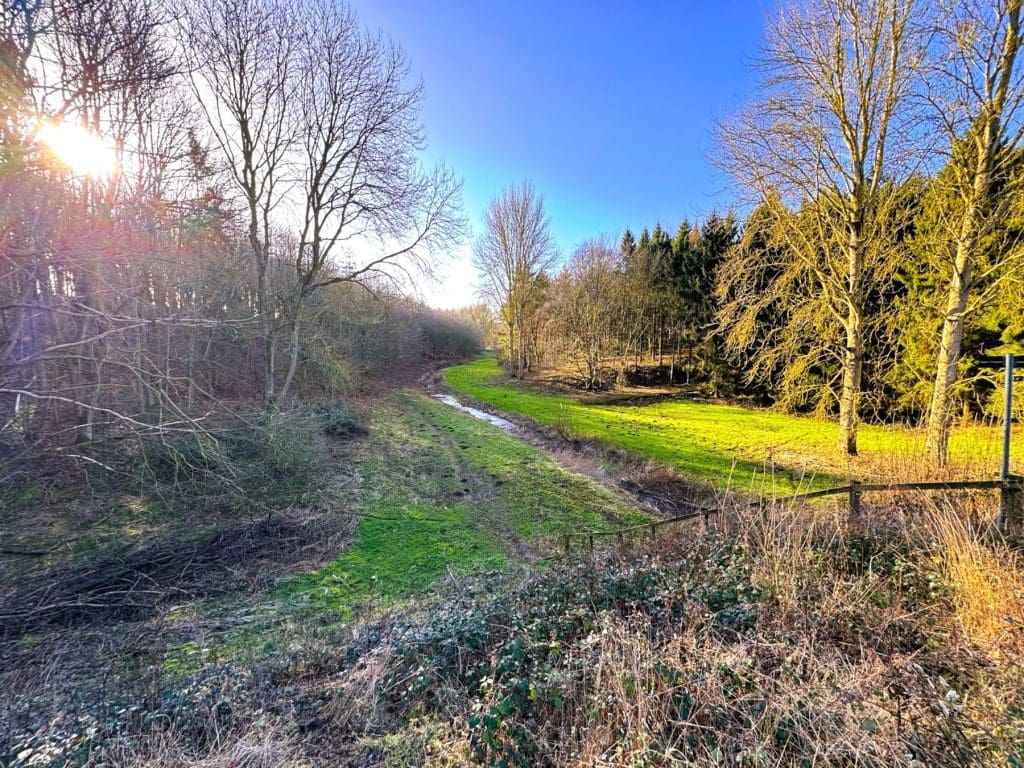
[474,0,1024,464]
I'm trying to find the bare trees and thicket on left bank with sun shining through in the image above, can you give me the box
[0,0,462,483]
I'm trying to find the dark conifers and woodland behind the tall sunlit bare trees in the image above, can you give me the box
[493,195,1024,424]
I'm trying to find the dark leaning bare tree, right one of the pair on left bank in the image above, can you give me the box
[281,0,465,396]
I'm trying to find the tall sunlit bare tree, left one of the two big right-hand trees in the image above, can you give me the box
[718,0,924,454]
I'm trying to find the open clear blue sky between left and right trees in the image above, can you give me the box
[352,0,774,306]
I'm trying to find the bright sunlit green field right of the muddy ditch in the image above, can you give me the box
[444,357,1024,494]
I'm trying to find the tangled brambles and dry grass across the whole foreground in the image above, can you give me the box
[3,495,1024,767]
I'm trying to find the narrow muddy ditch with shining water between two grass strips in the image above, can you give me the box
[419,371,718,517]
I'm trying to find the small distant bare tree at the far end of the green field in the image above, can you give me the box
[473,182,557,379]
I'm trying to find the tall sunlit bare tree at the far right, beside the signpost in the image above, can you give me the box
[926,0,1024,464]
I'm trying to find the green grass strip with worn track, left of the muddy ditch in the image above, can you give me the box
[278,392,646,612]
